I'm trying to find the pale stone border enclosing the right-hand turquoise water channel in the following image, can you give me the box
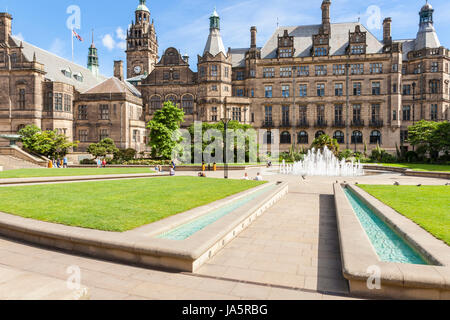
[334,184,450,300]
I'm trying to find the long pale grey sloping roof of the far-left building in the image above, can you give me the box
[11,36,106,92]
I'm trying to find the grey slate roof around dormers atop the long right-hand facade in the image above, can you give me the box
[261,22,383,59]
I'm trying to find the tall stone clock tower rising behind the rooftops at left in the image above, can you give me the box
[125,0,158,79]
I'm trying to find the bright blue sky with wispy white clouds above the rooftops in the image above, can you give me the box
[0,0,450,76]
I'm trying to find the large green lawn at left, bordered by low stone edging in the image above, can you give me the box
[0,177,264,232]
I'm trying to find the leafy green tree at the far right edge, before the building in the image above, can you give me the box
[408,120,450,160]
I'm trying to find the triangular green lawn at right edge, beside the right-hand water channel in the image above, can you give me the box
[359,185,450,245]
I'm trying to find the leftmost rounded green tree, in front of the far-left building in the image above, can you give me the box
[19,125,78,158]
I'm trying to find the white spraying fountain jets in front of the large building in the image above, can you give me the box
[280,147,364,177]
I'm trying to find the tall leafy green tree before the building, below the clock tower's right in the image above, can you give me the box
[147,101,184,160]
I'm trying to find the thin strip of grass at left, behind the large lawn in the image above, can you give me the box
[0,168,154,179]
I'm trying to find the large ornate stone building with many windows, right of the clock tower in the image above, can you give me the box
[138,0,450,152]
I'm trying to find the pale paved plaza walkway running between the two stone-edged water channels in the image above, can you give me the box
[0,168,446,300]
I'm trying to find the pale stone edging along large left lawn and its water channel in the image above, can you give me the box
[0,183,288,272]
